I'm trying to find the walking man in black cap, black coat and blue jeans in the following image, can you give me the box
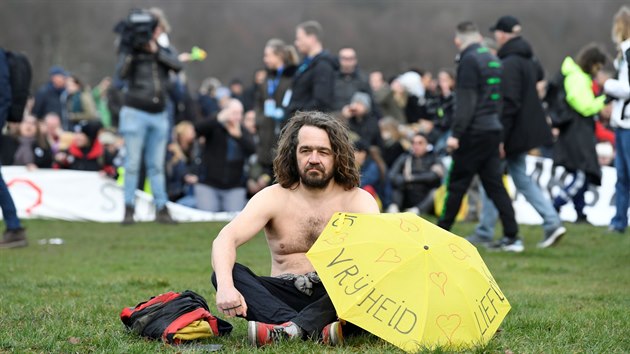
[468,16,567,248]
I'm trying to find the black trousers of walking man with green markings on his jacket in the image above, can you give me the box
[438,132,518,237]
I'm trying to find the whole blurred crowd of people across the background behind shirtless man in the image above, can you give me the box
[1,7,629,252]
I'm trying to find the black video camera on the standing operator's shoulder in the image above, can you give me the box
[114,9,158,51]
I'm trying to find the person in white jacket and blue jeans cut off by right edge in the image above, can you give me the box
[604,6,630,233]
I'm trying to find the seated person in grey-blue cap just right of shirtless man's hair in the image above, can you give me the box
[341,92,382,147]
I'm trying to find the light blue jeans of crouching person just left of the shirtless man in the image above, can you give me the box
[195,183,247,212]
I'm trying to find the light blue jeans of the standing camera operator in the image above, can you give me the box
[120,106,169,209]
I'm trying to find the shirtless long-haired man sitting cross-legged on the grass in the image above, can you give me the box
[212,112,379,346]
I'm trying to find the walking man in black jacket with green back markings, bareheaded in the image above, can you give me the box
[438,22,524,252]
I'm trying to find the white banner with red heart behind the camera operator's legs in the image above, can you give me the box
[2,166,234,222]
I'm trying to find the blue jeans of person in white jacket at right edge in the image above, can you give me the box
[610,129,630,231]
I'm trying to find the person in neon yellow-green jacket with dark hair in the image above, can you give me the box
[552,44,606,222]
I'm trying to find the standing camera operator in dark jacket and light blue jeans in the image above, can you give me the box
[116,10,182,225]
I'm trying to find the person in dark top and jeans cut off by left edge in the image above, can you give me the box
[0,48,30,248]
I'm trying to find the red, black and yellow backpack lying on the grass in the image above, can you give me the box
[120,290,232,344]
